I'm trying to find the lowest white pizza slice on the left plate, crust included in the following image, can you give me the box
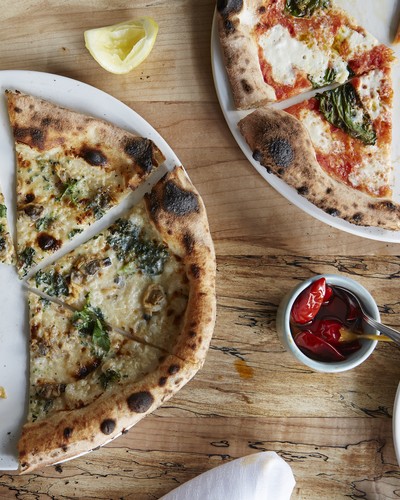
[18,294,200,473]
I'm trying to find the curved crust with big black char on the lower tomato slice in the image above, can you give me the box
[238,107,400,230]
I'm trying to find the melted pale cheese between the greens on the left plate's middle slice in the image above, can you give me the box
[30,202,189,352]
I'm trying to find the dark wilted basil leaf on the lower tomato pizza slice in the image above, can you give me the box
[315,82,376,145]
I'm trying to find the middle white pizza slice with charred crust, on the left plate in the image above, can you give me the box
[27,167,215,363]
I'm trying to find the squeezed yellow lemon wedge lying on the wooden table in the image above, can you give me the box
[84,17,158,75]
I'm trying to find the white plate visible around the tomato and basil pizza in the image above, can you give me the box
[211,0,400,242]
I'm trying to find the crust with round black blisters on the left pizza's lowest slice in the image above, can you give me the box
[18,355,200,473]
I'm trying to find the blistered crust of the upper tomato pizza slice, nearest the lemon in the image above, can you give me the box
[217,0,276,109]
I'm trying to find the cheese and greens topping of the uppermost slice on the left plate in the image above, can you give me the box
[16,144,134,278]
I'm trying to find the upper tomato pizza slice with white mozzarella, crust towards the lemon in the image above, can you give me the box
[217,0,395,109]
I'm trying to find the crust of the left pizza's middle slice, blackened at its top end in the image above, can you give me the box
[145,167,216,365]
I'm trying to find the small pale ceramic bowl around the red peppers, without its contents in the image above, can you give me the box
[276,274,380,373]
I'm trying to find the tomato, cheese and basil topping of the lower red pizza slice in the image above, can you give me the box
[285,67,394,199]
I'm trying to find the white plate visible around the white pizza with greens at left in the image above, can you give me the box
[0,71,180,470]
